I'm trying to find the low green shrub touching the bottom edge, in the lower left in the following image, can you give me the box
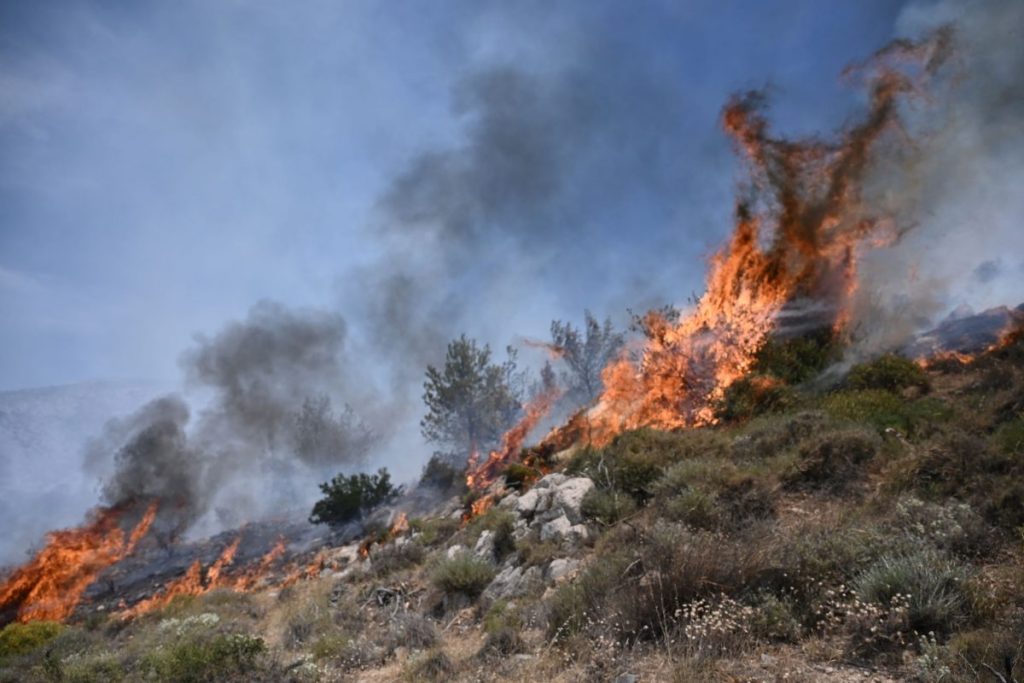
[145,634,266,683]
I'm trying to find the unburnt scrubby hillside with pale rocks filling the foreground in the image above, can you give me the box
[0,327,1024,682]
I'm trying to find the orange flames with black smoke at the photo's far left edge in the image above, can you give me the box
[0,503,157,622]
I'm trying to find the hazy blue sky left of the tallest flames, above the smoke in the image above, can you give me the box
[0,0,1007,389]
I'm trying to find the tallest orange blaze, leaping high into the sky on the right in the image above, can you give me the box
[573,34,948,445]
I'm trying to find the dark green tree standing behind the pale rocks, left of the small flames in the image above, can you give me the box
[420,335,522,462]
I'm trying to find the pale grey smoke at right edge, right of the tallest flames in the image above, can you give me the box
[856,0,1024,353]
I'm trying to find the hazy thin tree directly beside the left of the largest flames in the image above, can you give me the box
[551,310,626,405]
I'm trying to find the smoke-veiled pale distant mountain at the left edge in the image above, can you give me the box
[0,381,167,564]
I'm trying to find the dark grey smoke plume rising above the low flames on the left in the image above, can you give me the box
[86,302,376,537]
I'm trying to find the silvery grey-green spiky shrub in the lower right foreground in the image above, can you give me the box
[854,547,970,634]
